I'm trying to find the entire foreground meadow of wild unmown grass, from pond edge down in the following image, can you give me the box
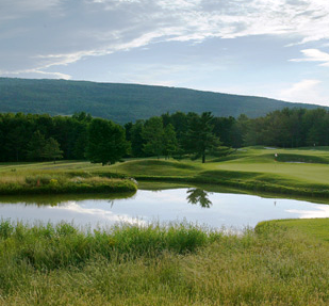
[0,221,329,306]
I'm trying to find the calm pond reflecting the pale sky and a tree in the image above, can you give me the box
[0,183,329,230]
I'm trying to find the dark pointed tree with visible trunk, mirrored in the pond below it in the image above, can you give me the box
[187,112,220,163]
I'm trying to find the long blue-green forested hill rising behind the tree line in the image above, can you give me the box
[0,78,318,123]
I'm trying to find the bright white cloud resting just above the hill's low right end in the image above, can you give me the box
[279,79,328,106]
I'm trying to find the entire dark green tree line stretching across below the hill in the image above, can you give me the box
[0,108,329,164]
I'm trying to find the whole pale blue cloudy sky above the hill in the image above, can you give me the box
[0,0,329,106]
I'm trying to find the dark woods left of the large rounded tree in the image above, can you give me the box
[0,113,92,162]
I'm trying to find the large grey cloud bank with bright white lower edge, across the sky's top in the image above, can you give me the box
[0,0,329,79]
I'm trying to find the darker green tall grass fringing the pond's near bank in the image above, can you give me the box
[0,220,221,271]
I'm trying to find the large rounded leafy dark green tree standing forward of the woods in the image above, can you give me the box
[86,119,129,166]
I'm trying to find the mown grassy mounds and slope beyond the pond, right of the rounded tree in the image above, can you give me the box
[109,147,329,197]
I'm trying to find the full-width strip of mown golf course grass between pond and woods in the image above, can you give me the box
[0,147,329,198]
